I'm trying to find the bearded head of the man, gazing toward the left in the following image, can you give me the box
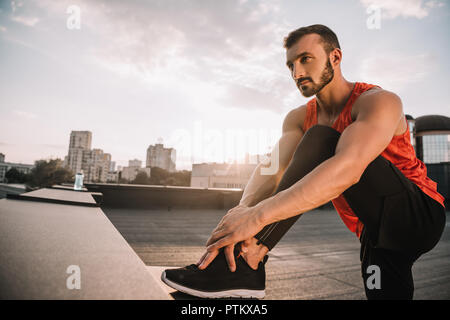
[284,24,342,97]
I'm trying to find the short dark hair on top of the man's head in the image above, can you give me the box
[284,24,341,53]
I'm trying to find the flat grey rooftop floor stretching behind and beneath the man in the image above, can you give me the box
[102,208,450,300]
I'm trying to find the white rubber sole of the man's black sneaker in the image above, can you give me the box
[161,271,266,299]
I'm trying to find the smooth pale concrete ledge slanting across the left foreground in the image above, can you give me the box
[0,188,172,300]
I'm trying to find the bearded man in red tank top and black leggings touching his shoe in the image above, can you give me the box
[162,25,445,299]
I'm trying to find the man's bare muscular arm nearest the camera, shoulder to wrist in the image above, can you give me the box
[255,91,403,225]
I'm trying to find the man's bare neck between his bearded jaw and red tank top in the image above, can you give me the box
[316,76,355,115]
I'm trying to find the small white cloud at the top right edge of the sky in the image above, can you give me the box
[360,0,445,19]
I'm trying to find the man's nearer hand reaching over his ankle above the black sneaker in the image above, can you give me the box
[197,205,264,272]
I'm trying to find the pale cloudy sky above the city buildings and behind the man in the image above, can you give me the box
[0,0,450,170]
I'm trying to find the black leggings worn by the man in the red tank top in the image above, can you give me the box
[255,125,445,299]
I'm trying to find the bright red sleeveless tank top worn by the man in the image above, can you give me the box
[303,82,444,238]
